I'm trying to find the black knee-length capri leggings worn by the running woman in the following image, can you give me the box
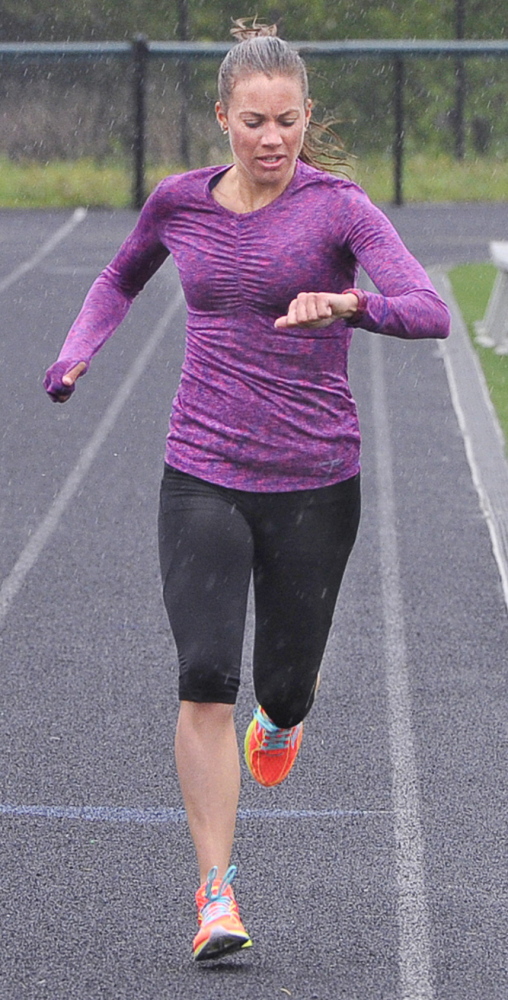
[159,465,360,728]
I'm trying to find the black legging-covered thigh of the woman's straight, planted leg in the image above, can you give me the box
[159,470,253,704]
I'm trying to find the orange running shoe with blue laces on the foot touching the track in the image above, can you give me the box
[192,865,252,962]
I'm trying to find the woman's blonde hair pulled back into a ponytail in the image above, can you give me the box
[218,17,349,176]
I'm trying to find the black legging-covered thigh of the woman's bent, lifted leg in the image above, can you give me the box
[254,477,360,725]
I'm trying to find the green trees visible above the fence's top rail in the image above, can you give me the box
[0,0,508,41]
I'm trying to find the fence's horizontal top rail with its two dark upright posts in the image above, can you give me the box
[0,36,508,209]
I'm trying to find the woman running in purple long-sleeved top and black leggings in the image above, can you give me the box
[45,22,449,960]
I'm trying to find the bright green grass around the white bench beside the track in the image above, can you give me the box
[449,264,508,444]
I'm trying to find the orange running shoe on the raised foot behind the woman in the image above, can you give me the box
[244,705,303,788]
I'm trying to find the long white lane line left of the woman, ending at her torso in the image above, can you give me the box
[0,291,183,628]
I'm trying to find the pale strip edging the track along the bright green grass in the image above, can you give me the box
[432,269,508,608]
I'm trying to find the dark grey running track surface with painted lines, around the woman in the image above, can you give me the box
[0,199,508,1000]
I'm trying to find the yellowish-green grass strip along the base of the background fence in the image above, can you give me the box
[0,154,508,208]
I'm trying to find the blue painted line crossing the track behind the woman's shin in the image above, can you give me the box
[0,803,388,825]
